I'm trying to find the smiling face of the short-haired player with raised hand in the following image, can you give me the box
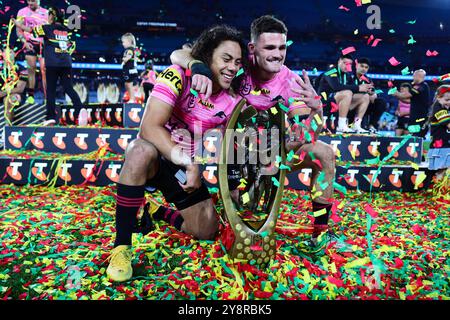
[248,32,287,79]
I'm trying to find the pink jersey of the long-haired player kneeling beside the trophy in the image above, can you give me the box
[150,65,241,152]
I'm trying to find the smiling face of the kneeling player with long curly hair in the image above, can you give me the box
[209,40,242,92]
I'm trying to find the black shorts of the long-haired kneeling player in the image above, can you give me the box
[146,156,211,210]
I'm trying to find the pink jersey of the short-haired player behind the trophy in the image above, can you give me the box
[239,66,306,111]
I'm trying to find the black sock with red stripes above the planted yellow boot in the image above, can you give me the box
[114,183,145,247]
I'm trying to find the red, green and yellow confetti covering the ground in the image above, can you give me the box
[0,185,450,300]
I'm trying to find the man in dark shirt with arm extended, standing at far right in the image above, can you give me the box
[394,69,430,138]
